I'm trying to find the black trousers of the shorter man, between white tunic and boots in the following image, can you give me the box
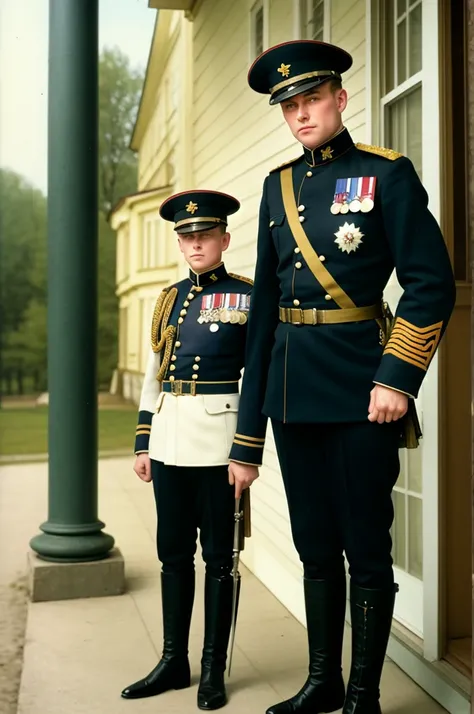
[151,460,235,575]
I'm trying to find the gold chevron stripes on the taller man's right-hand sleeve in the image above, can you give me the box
[384,317,443,372]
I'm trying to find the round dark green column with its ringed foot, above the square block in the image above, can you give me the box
[30,0,114,562]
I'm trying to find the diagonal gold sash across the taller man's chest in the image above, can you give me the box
[280,166,356,308]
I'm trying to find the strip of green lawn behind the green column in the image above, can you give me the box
[0,407,137,456]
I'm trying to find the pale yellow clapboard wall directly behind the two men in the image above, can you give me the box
[192,0,366,618]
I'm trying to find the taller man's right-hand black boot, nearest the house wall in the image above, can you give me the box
[343,583,398,714]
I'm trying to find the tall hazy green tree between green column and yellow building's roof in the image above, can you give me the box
[99,48,143,214]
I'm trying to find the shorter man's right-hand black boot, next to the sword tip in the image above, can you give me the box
[197,573,233,710]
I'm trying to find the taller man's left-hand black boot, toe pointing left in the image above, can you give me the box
[267,576,346,714]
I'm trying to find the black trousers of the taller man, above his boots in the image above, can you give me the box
[272,421,399,588]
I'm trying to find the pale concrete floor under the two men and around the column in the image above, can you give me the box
[0,458,445,714]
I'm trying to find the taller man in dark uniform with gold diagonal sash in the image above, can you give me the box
[229,41,455,714]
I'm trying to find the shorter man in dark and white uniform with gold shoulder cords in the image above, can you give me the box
[122,191,252,710]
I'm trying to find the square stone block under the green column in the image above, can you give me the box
[28,548,125,602]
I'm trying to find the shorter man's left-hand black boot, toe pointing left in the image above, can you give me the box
[122,571,194,699]
